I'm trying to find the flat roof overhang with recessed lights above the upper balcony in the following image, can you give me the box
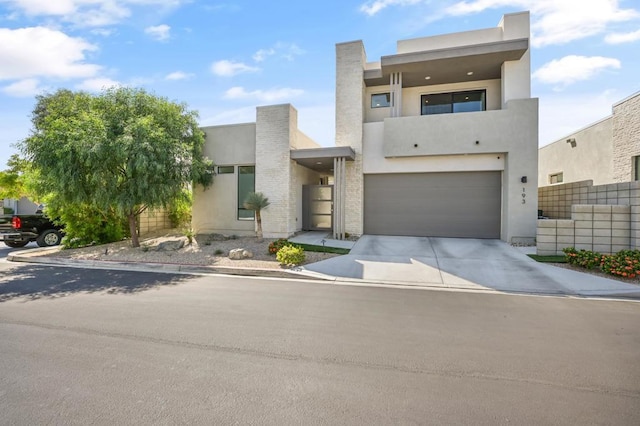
[364,38,529,87]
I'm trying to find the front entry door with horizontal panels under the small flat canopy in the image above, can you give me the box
[302,185,333,231]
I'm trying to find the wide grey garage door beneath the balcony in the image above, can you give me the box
[364,171,502,238]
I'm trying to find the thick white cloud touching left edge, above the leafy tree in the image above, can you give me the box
[0,27,101,80]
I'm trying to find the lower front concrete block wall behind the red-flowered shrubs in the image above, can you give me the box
[536,204,635,255]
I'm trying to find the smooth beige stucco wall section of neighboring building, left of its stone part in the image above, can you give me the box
[538,117,614,187]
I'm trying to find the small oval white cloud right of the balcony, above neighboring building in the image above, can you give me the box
[533,55,621,86]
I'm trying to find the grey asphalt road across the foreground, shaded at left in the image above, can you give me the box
[0,263,640,425]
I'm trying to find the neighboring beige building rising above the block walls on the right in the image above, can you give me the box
[538,92,640,187]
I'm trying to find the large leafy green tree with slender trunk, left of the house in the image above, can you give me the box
[21,87,213,247]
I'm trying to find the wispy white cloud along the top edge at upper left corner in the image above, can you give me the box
[0,0,189,27]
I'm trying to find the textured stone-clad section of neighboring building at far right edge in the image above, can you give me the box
[613,92,640,182]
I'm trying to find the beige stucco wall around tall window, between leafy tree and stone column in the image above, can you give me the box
[192,123,256,235]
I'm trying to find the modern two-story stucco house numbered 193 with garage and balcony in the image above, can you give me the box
[193,12,538,242]
